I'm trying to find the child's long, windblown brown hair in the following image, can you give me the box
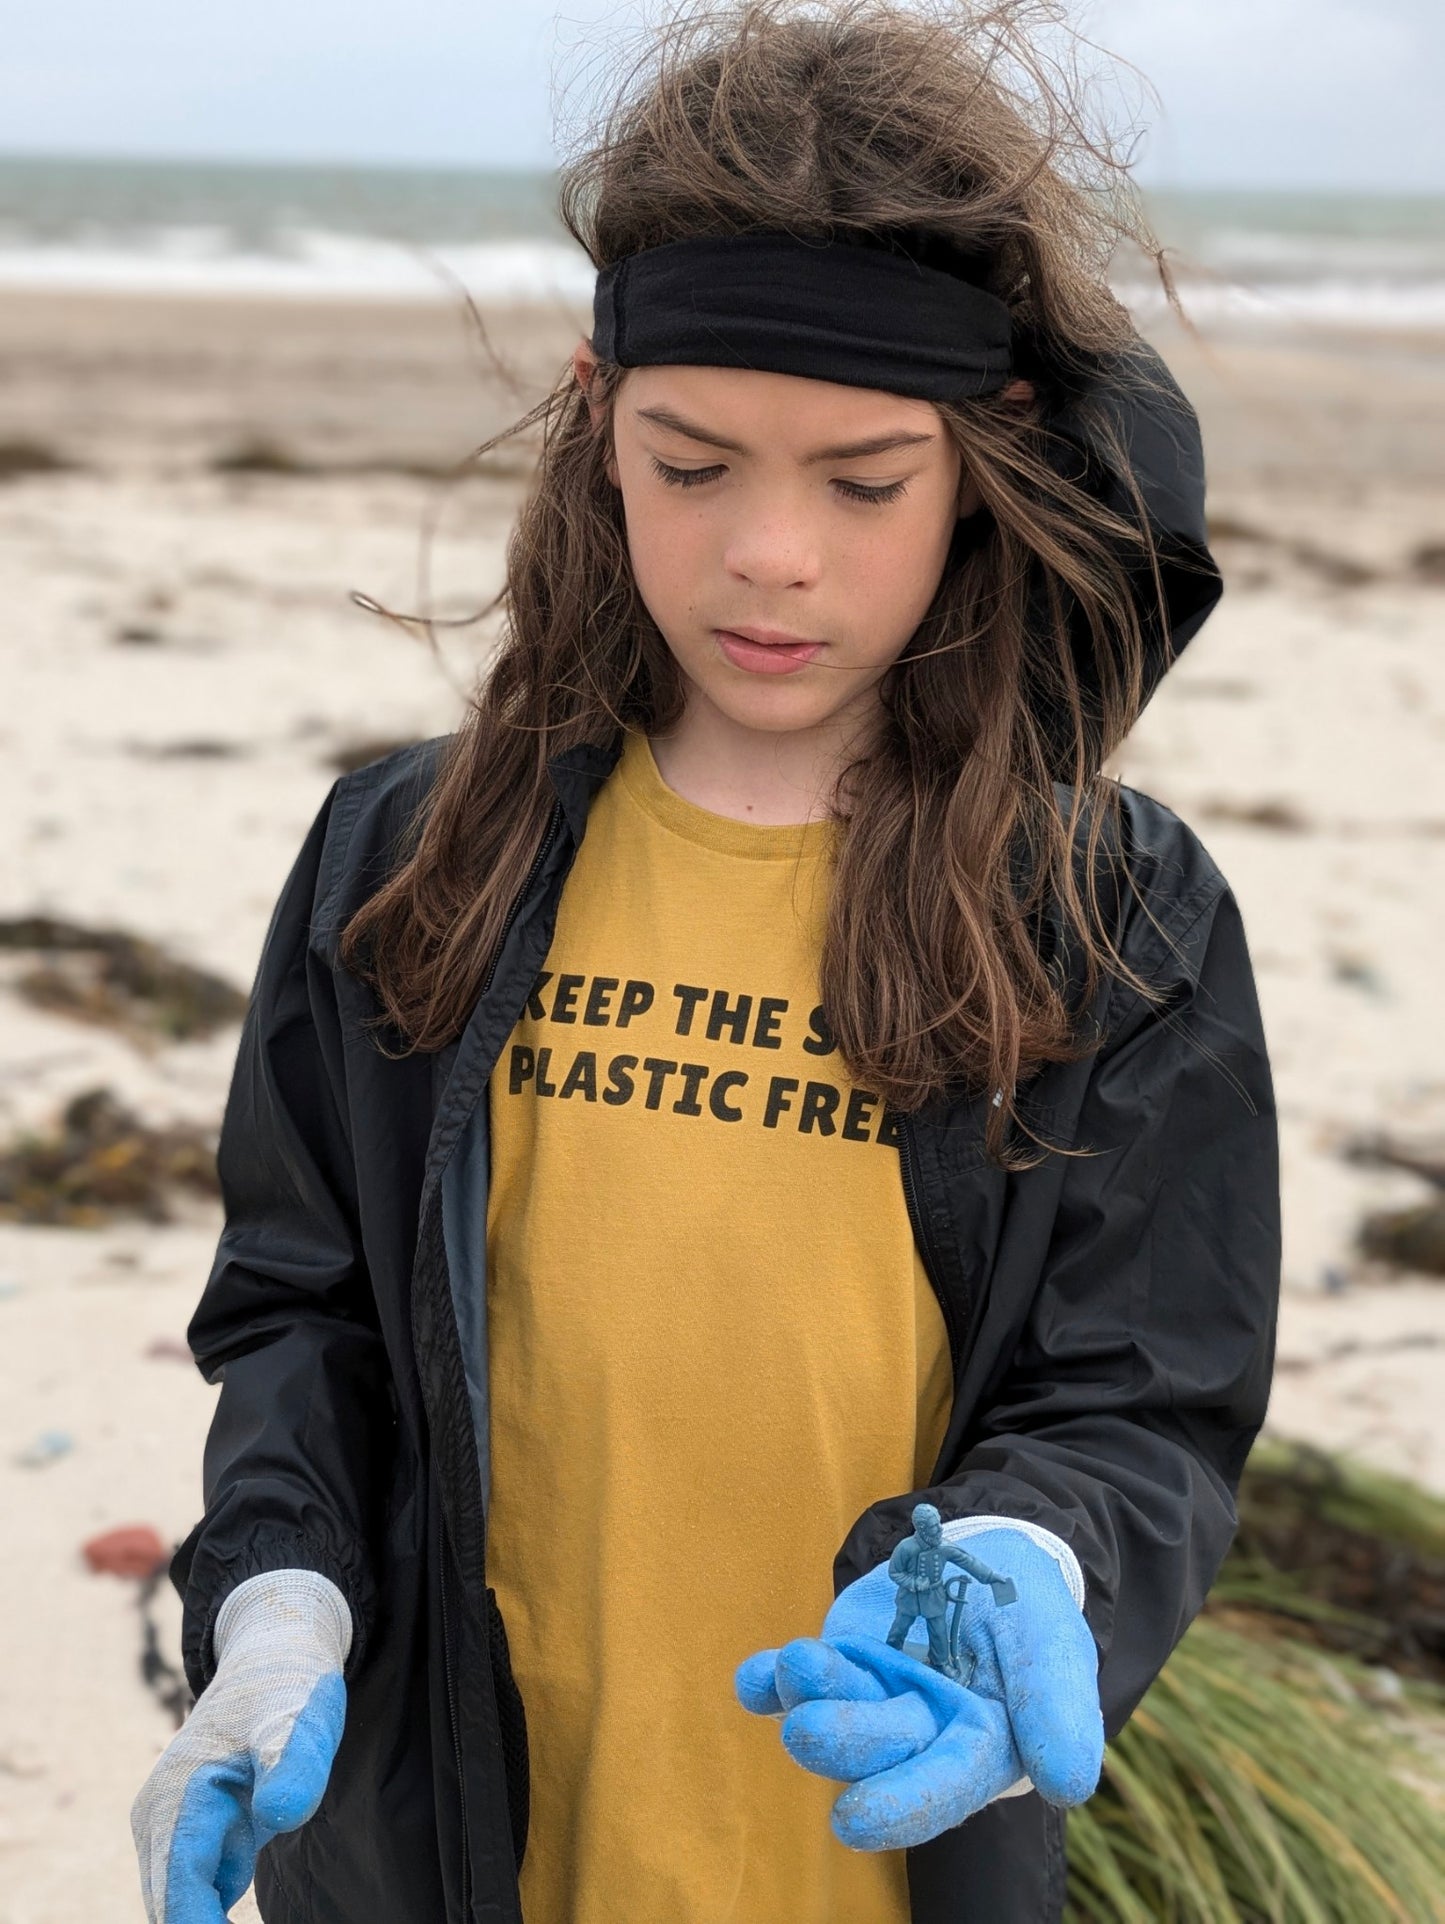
[342,0,1200,1168]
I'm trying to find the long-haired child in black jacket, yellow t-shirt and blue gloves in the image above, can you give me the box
[135,0,1278,1924]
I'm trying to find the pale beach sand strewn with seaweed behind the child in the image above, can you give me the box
[0,296,1445,1924]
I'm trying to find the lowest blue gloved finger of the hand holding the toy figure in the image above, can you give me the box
[831,1693,1020,1851]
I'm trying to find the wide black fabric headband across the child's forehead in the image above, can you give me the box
[593,231,1012,400]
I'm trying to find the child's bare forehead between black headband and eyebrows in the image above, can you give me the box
[618,366,947,458]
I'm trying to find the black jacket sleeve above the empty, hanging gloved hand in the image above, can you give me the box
[171,783,393,1693]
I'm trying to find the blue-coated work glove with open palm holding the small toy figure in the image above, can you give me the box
[735,1516,1104,1851]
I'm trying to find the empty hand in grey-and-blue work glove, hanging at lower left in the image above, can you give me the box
[131,1570,352,1924]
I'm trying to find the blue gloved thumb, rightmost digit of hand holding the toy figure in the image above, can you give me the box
[995,1610,1104,1805]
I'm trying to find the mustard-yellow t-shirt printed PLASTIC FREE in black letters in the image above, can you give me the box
[487,735,952,1924]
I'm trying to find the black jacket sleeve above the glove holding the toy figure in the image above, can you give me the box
[845,885,1280,1737]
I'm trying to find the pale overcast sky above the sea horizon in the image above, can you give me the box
[0,0,1445,192]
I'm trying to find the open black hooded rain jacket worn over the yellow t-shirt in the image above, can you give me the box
[171,346,1280,1924]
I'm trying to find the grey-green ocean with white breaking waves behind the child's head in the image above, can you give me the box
[0,156,1445,329]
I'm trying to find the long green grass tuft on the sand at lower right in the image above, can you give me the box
[1066,1445,1445,1924]
